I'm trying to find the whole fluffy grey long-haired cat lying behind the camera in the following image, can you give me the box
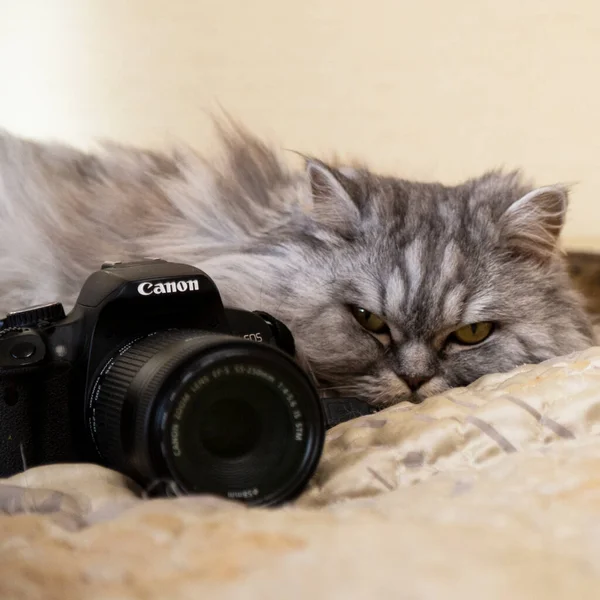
[0,126,595,406]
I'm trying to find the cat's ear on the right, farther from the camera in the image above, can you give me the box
[500,185,569,260]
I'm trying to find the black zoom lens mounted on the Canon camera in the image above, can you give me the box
[88,330,325,505]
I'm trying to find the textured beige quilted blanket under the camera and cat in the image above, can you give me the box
[0,347,600,600]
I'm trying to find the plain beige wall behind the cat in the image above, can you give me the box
[0,0,600,248]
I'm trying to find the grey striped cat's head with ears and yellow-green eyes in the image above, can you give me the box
[262,163,593,405]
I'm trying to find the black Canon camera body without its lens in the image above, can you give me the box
[0,259,294,477]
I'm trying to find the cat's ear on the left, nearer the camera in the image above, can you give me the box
[306,159,360,235]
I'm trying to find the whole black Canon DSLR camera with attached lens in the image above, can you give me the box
[0,259,371,505]
